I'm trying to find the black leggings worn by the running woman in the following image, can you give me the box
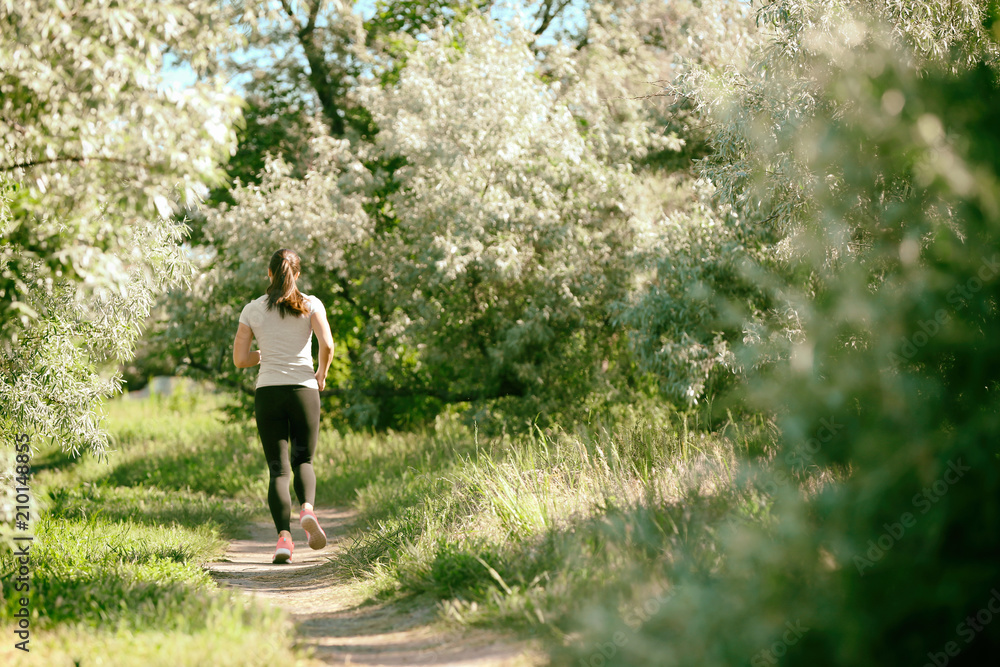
[254,385,319,533]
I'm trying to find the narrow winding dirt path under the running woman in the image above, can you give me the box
[205,508,544,667]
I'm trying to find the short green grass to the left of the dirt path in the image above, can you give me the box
[0,393,305,666]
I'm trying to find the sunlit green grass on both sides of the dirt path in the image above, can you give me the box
[0,386,823,665]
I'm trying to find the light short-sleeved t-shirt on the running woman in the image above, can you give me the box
[240,294,326,388]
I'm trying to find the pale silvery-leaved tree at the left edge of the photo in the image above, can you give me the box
[0,0,239,536]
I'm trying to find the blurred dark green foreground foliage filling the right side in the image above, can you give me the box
[568,3,1000,665]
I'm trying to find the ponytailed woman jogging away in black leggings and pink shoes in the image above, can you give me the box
[233,248,333,563]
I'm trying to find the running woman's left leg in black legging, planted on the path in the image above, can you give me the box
[254,387,292,534]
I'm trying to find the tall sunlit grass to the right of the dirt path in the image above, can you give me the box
[324,413,808,655]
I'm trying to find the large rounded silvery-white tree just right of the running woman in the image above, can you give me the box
[365,19,648,420]
